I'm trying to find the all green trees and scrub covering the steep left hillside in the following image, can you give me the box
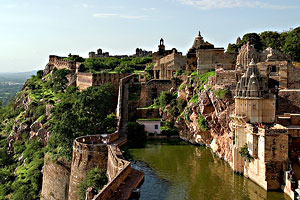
[0,70,117,200]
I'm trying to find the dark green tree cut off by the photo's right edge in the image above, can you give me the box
[283,27,300,62]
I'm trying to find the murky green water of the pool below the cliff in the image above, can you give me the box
[129,140,289,200]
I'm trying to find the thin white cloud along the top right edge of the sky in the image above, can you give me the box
[178,0,300,10]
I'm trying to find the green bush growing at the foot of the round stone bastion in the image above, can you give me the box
[77,167,108,200]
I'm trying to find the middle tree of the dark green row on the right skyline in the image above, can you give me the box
[259,31,282,50]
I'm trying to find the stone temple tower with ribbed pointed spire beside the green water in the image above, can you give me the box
[232,59,276,173]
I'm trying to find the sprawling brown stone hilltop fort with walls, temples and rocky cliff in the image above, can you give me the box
[0,31,300,200]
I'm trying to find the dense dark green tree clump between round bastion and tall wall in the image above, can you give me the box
[47,84,117,160]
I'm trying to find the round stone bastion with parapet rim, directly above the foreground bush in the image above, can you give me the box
[69,135,107,200]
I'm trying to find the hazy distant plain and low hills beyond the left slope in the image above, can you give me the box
[0,70,37,105]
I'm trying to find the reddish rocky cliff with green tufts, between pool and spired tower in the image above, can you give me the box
[161,73,234,163]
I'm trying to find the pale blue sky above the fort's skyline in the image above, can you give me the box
[0,0,300,72]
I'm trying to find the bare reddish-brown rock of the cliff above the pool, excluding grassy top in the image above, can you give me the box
[176,78,234,163]
